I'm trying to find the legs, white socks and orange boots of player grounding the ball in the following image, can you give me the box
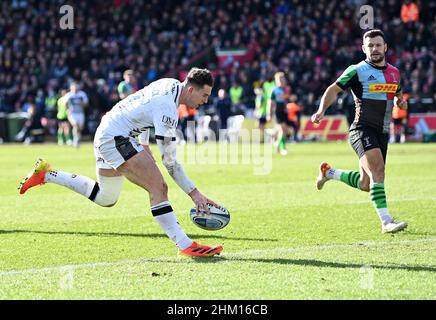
[18,154,223,257]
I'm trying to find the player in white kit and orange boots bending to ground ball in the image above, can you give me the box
[19,68,223,256]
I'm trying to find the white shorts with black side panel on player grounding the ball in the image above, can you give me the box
[94,132,144,169]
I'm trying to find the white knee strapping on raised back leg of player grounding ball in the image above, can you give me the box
[89,176,124,207]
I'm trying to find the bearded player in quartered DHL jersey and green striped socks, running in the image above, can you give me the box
[312,29,407,233]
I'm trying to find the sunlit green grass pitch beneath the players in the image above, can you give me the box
[0,143,436,300]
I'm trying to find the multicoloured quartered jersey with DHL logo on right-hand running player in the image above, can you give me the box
[336,60,401,133]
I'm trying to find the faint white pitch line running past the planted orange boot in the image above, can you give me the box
[0,238,436,276]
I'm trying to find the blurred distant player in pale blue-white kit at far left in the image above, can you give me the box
[65,82,89,147]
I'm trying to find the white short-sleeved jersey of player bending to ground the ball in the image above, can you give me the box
[99,78,182,140]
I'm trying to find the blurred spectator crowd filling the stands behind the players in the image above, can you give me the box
[0,0,436,139]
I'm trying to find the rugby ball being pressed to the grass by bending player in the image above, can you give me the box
[189,203,230,230]
